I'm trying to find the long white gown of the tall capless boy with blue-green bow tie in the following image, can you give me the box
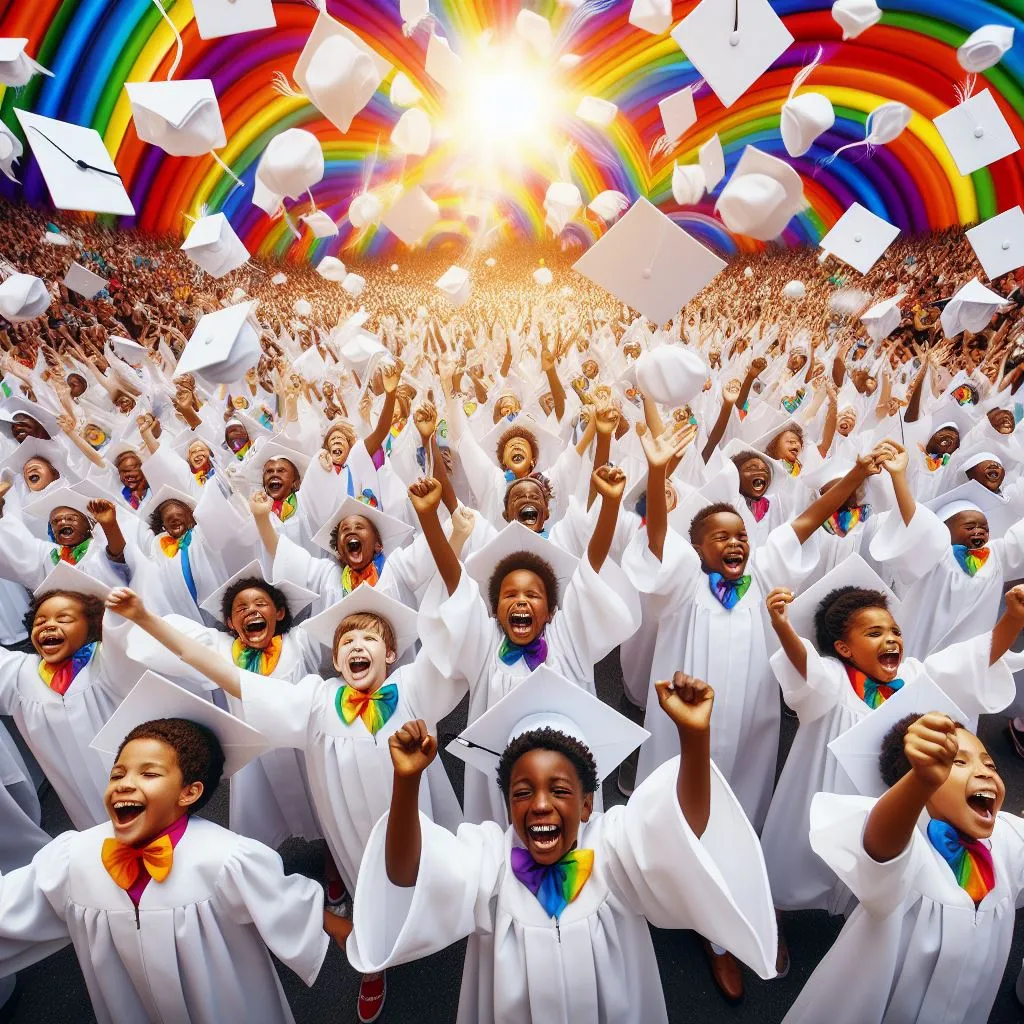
[623,523,817,828]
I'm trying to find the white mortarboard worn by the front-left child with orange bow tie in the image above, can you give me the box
[89,672,270,778]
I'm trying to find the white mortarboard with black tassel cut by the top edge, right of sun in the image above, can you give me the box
[672,0,793,106]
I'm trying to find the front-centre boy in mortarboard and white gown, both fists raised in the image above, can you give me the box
[347,669,775,1024]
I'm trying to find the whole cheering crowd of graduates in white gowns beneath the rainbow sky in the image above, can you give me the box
[0,193,1024,1024]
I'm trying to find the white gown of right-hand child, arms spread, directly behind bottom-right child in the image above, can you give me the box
[761,633,1014,913]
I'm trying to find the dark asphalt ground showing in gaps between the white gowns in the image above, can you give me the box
[10,654,1024,1024]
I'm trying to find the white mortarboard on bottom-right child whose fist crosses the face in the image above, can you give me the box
[828,676,970,797]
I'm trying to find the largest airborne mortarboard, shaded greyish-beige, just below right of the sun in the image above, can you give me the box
[573,197,725,327]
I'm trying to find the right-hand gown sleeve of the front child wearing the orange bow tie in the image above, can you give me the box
[217,836,331,985]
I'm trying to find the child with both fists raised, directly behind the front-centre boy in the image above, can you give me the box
[409,466,640,823]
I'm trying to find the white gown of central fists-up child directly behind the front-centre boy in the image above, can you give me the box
[419,558,640,826]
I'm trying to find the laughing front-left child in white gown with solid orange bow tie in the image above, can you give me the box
[0,673,348,1024]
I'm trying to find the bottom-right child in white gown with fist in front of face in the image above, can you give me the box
[784,708,1024,1024]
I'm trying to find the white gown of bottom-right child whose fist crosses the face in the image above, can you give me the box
[783,794,1024,1024]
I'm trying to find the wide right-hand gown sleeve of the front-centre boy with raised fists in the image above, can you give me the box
[596,757,778,979]
